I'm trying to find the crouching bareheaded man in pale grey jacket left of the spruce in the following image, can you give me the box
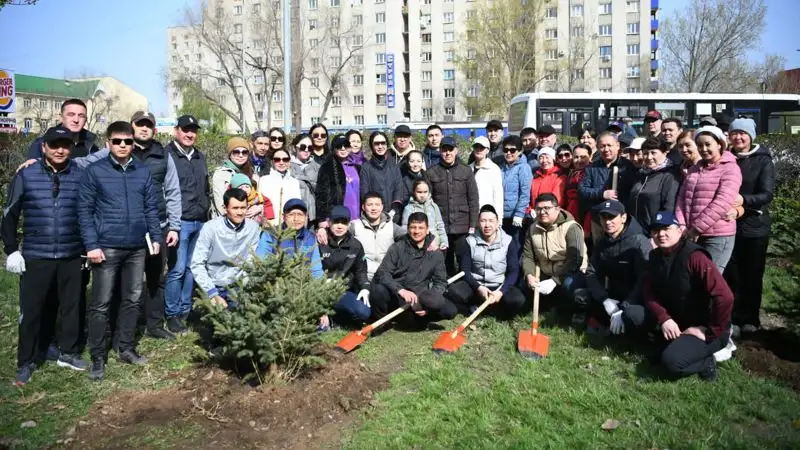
[190,189,261,308]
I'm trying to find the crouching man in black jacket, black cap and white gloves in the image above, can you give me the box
[576,200,653,334]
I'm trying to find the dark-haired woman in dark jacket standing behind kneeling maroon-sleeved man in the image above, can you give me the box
[625,137,681,236]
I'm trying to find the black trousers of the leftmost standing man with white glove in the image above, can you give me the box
[17,257,83,366]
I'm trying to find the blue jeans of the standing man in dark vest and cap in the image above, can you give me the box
[164,220,203,317]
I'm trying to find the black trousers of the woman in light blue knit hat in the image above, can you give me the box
[725,236,769,326]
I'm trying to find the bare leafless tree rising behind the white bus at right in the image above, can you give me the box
[662,0,767,92]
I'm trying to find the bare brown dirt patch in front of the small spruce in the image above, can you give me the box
[68,352,389,449]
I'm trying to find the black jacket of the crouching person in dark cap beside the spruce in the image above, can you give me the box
[319,229,369,293]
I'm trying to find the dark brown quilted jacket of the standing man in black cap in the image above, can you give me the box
[428,161,480,234]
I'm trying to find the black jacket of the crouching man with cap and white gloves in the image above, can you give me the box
[586,215,653,309]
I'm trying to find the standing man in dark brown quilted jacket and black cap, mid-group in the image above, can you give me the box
[428,136,480,276]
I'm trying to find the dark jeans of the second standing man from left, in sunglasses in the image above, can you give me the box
[89,248,146,358]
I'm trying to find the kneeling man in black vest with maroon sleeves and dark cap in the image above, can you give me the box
[644,211,733,381]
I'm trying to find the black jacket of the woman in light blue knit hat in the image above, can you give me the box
[736,145,775,237]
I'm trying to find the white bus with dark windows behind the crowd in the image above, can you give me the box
[508,92,800,136]
